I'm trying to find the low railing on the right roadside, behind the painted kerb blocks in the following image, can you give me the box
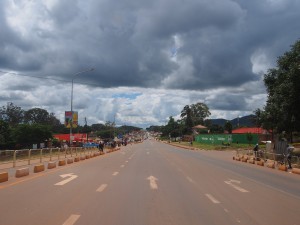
[236,149,300,168]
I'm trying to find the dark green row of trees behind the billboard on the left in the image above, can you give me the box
[0,102,140,150]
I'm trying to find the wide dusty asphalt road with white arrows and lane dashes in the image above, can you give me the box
[0,140,300,225]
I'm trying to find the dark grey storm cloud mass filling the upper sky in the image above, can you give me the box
[0,0,300,114]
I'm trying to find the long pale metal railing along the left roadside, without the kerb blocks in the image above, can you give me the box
[0,147,99,169]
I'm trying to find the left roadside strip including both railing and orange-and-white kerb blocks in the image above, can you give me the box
[0,147,120,183]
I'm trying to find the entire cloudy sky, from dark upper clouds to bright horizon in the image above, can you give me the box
[0,0,300,128]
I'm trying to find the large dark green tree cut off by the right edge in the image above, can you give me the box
[262,40,300,141]
